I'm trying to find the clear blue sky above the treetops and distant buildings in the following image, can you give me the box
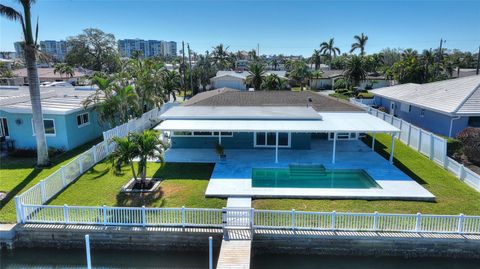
[0,0,480,56]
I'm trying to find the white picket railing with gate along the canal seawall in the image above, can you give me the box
[15,205,480,234]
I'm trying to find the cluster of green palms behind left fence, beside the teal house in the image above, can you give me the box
[84,58,181,127]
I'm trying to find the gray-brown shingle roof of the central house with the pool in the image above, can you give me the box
[184,89,363,112]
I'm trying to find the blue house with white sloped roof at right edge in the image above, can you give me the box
[371,75,480,137]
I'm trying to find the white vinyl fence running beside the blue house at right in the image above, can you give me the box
[350,98,480,191]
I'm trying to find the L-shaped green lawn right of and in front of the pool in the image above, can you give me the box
[254,135,480,215]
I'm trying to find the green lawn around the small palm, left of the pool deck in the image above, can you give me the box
[49,162,226,208]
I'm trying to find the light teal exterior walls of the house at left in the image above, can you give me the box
[0,110,104,150]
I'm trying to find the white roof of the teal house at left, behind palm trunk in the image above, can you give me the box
[0,87,94,115]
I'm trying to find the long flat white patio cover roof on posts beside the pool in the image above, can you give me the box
[155,113,400,133]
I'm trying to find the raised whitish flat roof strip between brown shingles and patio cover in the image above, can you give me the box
[160,106,322,120]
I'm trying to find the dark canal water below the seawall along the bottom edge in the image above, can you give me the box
[0,248,480,269]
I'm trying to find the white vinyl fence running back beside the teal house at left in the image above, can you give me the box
[15,103,173,222]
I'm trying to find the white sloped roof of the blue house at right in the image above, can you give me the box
[371,75,480,115]
